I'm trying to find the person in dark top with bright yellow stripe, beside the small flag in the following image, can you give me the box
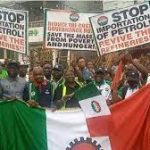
[54,70,82,108]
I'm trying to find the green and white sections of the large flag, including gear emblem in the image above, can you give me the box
[0,100,110,150]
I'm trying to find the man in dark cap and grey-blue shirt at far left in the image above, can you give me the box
[0,61,26,100]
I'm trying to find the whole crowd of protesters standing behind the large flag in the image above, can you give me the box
[0,54,150,109]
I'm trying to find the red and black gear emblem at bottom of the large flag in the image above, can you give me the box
[66,137,103,150]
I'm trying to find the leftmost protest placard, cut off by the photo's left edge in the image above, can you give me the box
[0,8,28,53]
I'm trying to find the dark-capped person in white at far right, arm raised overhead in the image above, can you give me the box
[110,54,147,100]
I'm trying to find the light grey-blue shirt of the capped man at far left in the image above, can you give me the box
[0,77,26,99]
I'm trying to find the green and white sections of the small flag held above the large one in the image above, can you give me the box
[75,83,111,118]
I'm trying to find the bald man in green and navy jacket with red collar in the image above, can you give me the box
[23,66,52,108]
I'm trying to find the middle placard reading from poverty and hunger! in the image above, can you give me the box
[44,9,96,51]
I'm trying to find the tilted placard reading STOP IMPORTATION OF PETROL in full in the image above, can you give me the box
[90,2,150,55]
